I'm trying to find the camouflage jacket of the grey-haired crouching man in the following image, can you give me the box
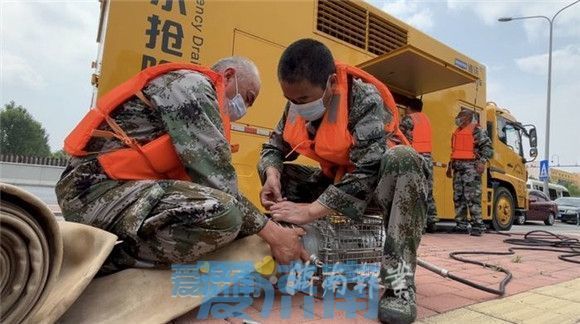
[57,70,266,234]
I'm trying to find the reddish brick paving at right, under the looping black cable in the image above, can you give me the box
[417,230,580,319]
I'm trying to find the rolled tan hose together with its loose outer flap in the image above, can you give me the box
[0,183,117,323]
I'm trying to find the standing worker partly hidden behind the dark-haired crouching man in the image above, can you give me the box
[399,98,439,233]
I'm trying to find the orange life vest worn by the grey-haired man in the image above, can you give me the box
[64,63,230,180]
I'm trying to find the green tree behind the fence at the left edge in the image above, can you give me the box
[0,101,51,157]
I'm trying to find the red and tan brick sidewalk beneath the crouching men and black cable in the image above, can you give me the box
[175,229,580,323]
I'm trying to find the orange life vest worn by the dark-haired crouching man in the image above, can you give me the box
[283,62,409,181]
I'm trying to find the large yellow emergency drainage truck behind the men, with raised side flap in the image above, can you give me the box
[92,0,537,230]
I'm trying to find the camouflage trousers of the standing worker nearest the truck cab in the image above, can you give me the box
[453,160,485,229]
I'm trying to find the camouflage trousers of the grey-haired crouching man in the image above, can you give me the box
[57,180,257,273]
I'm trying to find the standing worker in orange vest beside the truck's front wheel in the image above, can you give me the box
[447,109,493,236]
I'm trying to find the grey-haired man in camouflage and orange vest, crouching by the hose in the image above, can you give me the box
[56,57,305,271]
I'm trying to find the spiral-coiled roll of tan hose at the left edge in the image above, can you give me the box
[0,184,63,323]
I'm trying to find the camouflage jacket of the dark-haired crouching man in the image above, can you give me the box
[258,79,392,217]
